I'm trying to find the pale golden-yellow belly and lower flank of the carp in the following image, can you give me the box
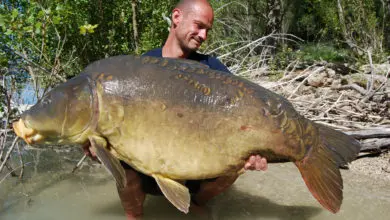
[103,101,284,179]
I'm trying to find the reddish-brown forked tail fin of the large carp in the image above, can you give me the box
[295,124,360,213]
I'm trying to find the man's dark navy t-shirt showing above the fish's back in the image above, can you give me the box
[142,48,231,74]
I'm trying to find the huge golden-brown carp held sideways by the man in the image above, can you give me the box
[14,56,360,213]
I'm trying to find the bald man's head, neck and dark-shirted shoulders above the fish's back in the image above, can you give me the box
[144,0,230,73]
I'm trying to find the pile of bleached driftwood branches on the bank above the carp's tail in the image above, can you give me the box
[268,64,390,156]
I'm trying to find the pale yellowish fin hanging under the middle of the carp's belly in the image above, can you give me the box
[152,174,191,213]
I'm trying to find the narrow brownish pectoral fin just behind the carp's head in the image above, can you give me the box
[89,136,126,189]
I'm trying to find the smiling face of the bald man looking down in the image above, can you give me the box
[176,7,213,51]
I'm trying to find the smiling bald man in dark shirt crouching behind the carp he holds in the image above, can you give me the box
[84,0,267,220]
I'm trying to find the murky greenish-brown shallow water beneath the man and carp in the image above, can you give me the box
[0,146,390,220]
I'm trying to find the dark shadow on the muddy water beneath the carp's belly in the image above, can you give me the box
[99,183,323,220]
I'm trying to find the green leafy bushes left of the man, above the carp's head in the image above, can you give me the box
[0,0,174,98]
